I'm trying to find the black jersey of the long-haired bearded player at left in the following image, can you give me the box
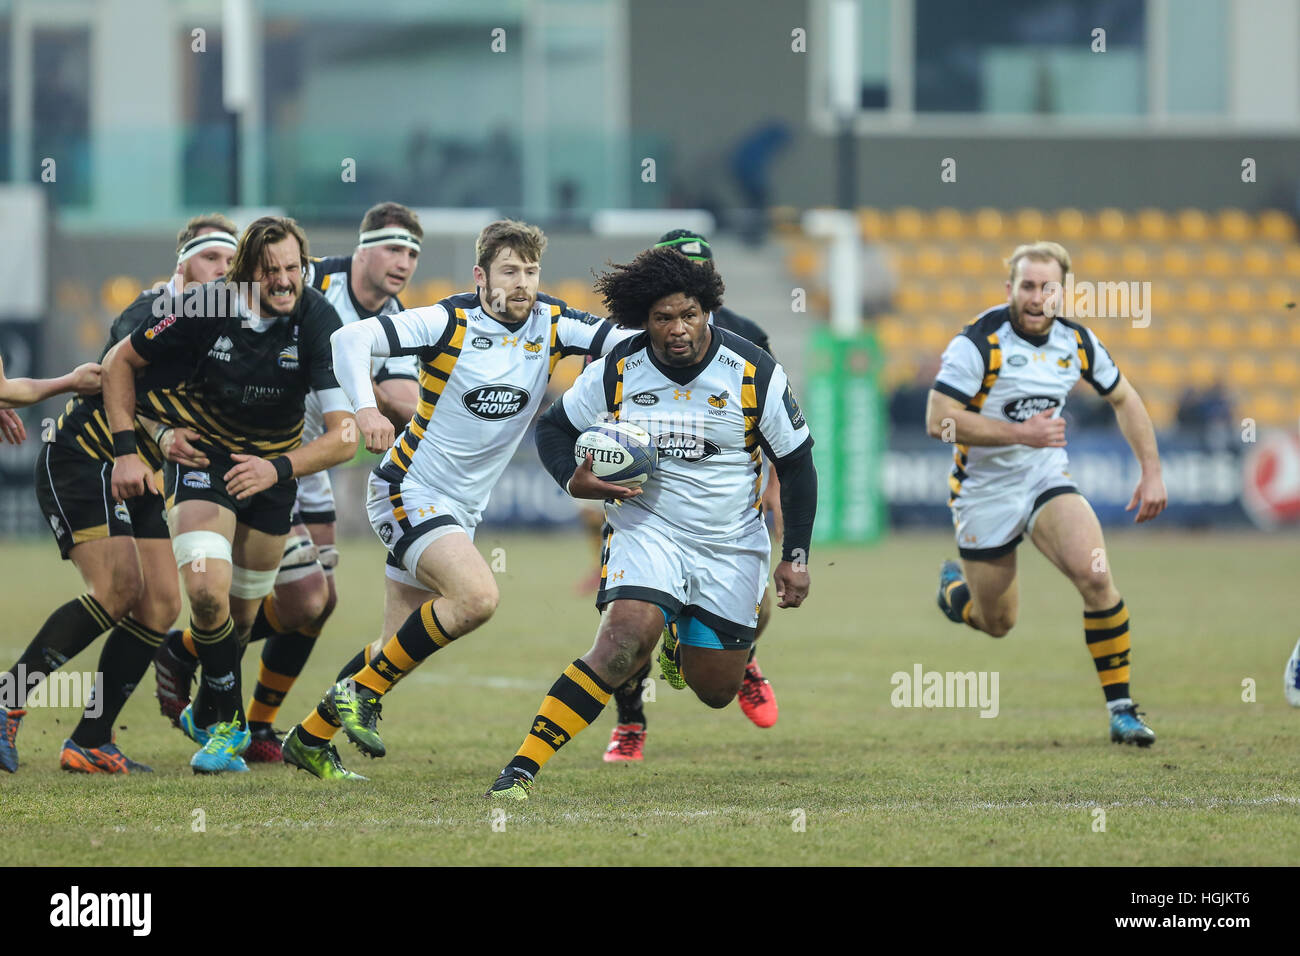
[131,284,341,457]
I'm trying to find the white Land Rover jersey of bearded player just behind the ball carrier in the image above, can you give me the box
[339,293,637,519]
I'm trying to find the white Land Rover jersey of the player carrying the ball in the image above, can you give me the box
[562,326,813,542]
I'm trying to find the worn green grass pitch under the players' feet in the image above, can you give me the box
[0,531,1300,866]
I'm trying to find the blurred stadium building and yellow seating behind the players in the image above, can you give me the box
[0,0,1300,540]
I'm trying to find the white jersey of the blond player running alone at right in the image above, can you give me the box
[935,306,1119,503]
